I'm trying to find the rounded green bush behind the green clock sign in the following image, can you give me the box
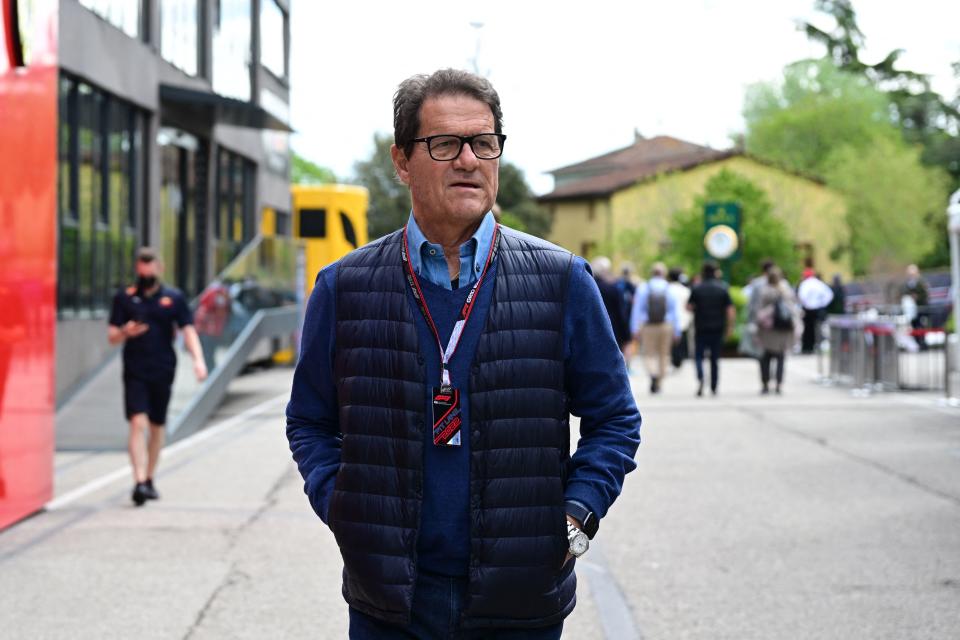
[663,169,800,285]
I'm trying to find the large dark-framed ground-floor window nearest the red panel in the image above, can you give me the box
[57,74,143,317]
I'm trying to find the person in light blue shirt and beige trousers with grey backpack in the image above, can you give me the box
[630,262,680,393]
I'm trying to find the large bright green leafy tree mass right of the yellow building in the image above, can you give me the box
[744,60,946,274]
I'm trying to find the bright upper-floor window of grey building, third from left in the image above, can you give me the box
[212,0,253,101]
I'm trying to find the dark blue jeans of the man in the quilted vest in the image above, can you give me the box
[350,571,563,640]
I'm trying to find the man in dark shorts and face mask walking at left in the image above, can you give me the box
[107,247,207,507]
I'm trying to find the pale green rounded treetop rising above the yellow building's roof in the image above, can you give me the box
[743,60,898,176]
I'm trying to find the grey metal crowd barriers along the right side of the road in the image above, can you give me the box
[820,314,952,395]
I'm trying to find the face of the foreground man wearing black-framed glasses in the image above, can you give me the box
[391,95,500,234]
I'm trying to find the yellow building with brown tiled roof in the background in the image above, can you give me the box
[539,136,850,277]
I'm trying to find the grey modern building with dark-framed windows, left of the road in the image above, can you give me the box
[56,0,290,403]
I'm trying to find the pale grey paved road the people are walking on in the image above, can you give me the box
[0,358,960,640]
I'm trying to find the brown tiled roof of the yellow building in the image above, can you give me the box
[539,136,739,202]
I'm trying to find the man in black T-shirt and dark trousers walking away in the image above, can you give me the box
[687,262,736,397]
